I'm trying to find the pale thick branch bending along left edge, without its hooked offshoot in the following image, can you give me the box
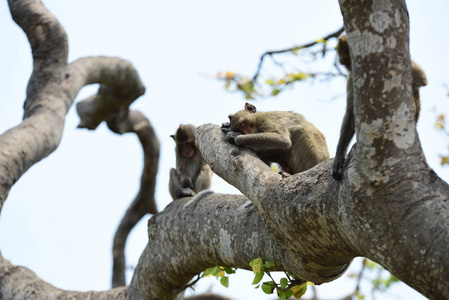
[0,0,71,211]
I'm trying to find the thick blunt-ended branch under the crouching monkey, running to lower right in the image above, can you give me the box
[196,124,449,299]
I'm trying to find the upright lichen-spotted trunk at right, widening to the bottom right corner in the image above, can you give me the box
[340,0,449,299]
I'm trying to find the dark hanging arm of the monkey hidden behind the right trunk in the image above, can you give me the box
[332,75,355,180]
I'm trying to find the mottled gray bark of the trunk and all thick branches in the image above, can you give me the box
[0,0,449,300]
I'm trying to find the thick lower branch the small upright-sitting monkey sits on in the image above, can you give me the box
[129,192,347,300]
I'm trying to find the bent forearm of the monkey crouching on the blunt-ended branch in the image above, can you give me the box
[234,132,292,152]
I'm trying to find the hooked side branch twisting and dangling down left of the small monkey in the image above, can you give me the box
[69,57,160,287]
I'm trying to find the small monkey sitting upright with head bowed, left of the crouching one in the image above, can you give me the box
[169,124,212,200]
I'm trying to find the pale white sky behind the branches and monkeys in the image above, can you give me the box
[0,0,449,299]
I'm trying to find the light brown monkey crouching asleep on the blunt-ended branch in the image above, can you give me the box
[222,103,329,176]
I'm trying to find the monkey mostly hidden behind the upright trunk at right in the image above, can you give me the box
[332,35,427,180]
